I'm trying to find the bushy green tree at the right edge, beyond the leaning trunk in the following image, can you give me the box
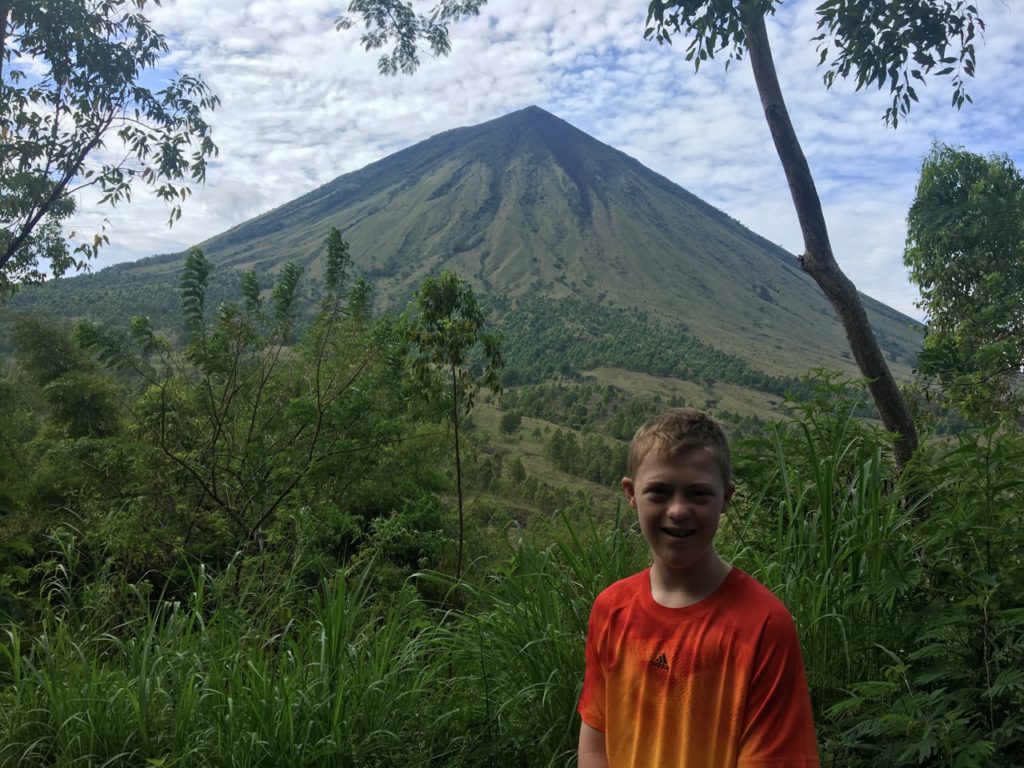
[903,143,1024,417]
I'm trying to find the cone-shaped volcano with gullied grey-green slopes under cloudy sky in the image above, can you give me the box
[14,108,921,375]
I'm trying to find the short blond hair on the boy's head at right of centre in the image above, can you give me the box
[629,408,732,485]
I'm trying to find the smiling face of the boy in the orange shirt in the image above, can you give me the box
[623,447,734,580]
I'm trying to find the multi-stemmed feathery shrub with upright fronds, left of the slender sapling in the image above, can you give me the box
[77,236,415,567]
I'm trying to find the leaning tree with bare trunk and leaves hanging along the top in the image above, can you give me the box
[339,0,984,466]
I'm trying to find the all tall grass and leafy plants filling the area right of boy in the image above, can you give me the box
[723,397,1024,768]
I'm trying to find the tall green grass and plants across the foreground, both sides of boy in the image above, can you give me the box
[0,384,1024,767]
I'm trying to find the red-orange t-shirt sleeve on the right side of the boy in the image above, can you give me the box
[738,608,819,768]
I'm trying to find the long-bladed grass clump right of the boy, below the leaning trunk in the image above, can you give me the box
[726,431,921,703]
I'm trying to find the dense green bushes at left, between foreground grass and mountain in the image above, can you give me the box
[3,240,443,593]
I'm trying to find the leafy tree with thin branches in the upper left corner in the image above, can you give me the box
[0,0,219,292]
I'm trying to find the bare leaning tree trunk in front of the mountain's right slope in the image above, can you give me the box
[744,12,918,468]
